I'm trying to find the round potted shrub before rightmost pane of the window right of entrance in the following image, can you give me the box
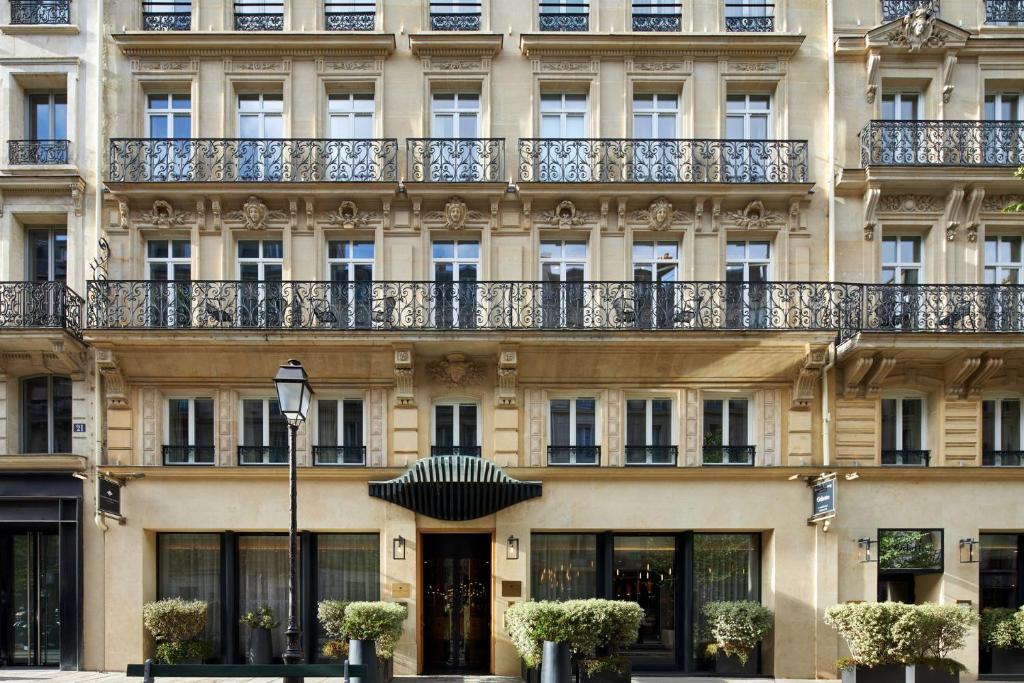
[702,600,774,676]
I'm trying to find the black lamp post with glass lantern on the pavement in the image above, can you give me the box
[273,359,313,683]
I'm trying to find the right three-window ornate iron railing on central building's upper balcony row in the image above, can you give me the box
[519,138,808,183]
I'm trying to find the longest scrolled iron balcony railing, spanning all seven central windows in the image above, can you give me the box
[88,281,862,335]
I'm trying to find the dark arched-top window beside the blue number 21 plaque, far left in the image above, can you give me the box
[22,375,72,454]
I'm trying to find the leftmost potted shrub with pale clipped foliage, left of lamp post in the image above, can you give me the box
[142,598,210,664]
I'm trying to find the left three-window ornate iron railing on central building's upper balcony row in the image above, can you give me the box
[106,138,398,182]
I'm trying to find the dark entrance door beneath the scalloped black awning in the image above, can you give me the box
[422,533,490,674]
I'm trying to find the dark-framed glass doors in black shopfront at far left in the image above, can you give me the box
[0,530,60,667]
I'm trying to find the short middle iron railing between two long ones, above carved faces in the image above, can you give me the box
[406,137,507,182]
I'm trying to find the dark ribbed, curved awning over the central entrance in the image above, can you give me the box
[370,456,541,521]
